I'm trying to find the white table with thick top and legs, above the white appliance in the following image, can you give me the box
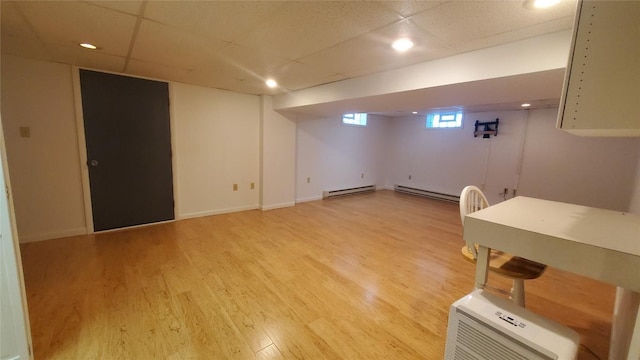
[464,196,640,360]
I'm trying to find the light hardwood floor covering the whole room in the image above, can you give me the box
[21,191,614,359]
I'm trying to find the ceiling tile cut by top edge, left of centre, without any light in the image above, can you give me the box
[145,1,286,42]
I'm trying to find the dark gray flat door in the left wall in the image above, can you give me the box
[80,70,174,231]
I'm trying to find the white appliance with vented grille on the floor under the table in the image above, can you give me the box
[445,290,580,360]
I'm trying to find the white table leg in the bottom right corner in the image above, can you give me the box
[609,287,640,360]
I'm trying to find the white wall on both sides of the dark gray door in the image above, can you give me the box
[2,57,268,242]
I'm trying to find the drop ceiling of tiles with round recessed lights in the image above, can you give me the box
[1,0,575,112]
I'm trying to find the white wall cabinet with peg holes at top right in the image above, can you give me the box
[557,0,640,136]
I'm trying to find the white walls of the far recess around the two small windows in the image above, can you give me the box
[296,105,640,211]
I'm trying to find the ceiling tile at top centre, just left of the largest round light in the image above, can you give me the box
[236,1,401,60]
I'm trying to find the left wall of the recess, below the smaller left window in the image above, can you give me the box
[296,115,389,202]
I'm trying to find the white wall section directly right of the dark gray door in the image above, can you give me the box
[170,83,260,218]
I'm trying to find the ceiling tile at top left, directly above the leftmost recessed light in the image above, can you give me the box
[17,1,136,56]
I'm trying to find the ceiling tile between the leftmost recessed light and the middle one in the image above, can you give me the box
[131,20,228,69]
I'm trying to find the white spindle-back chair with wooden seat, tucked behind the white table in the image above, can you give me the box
[460,185,547,307]
